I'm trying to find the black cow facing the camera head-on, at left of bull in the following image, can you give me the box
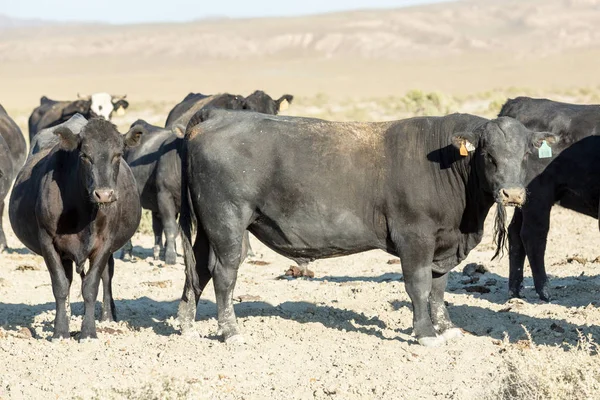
[9,118,141,339]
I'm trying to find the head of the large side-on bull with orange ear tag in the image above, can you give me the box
[452,117,559,258]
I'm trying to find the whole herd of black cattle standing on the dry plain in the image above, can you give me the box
[0,91,600,346]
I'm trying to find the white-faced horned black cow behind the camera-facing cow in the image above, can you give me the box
[29,93,129,143]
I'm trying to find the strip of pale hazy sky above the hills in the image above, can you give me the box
[0,0,448,23]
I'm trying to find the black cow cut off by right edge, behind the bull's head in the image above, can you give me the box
[499,97,600,301]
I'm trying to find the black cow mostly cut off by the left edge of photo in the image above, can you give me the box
[0,105,27,252]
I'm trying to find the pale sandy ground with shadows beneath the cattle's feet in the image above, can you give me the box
[0,198,600,399]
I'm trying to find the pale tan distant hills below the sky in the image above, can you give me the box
[0,0,600,60]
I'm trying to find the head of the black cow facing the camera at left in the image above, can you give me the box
[54,118,141,206]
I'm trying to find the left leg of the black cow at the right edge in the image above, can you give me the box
[508,208,526,298]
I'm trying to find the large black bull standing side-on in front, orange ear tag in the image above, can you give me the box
[179,110,552,345]
